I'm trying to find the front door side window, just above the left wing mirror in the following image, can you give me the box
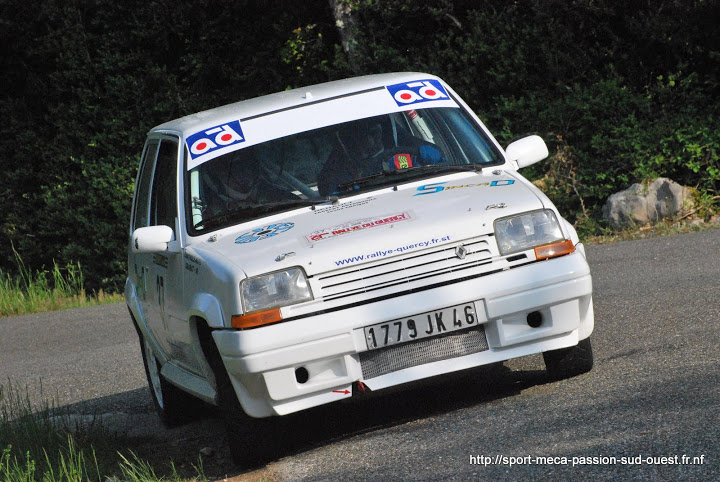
[150,139,178,229]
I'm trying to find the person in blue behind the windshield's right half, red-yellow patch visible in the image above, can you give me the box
[318,118,444,196]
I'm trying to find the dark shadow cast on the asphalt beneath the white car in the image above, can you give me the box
[57,364,548,479]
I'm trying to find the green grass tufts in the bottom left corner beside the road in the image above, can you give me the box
[0,382,207,482]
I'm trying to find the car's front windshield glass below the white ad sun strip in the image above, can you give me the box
[186,107,503,234]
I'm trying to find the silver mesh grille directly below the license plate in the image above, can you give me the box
[360,325,488,380]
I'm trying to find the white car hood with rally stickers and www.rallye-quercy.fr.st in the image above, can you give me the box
[196,172,543,276]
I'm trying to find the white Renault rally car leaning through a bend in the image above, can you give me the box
[125,73,594,463]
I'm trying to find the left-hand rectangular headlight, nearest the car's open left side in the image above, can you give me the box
[240,268,313,313]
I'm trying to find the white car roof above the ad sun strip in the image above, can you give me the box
[150,72,439,134]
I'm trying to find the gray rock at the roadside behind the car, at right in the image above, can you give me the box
[603,177,694,229]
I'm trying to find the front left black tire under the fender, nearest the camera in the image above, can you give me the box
[198,326,281,469]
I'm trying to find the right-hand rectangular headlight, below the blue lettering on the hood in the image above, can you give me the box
[495,209,572,256]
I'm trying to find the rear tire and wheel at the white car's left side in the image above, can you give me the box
[138,330,202,427]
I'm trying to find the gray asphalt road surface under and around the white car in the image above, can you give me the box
[0,230,720,480]
